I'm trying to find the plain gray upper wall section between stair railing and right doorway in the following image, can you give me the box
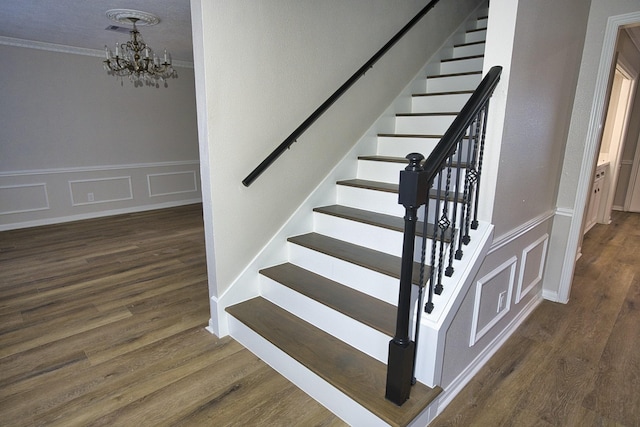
[493,0,589,236]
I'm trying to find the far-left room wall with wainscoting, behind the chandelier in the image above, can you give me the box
[0,45,201,229]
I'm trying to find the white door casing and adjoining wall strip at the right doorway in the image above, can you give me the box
[544,0,640,302]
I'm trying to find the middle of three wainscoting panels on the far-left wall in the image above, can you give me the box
[69,176,133,206]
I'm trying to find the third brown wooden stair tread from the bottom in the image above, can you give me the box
[287,233,422,284]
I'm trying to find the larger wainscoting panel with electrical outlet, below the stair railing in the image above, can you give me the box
[469,256,518,347]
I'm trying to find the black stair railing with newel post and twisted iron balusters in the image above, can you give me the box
[386,66,502,405]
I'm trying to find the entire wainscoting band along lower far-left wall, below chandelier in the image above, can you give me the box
[0,160,202,231]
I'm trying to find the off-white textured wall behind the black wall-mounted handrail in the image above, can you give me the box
[192,0,478,297]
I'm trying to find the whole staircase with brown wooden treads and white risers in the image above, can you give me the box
[226,8,487,426]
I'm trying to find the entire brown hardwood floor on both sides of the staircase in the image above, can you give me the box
[0,205,640,426]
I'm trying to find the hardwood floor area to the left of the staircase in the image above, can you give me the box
[0,205,344,426]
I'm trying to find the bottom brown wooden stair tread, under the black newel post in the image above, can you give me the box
[227,297,442,426]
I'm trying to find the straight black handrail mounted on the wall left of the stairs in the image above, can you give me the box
[242,0,440,187]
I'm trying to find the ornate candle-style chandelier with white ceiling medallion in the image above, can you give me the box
[103,9,178,87]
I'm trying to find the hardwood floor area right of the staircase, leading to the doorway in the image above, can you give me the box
[432,212,640,427]
